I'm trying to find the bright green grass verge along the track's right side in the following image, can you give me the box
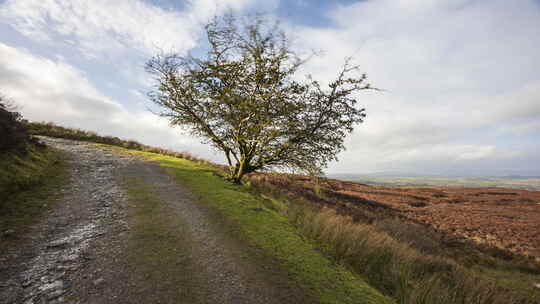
[120,151,393,304]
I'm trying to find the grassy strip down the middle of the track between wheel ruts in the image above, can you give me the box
[125,178,207,303]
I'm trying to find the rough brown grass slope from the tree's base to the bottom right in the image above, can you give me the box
[249,174,540,304]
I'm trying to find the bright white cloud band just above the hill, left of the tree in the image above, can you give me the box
[0,43,219,159]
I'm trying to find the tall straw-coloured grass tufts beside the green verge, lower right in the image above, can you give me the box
[288,207,536,304]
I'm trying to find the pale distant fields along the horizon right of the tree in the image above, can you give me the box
[331,175,540,190]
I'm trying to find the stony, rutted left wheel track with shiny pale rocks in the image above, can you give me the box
[0,138,130,303]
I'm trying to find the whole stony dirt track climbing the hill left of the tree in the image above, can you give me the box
[0,138,311,303]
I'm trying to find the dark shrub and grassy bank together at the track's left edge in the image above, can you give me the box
[0,103,66,234]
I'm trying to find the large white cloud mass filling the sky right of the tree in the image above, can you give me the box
[288,0,540,172]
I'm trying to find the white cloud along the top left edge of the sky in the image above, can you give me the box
[0,0,253,57]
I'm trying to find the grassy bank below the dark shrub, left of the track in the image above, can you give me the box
[0,146,69,232]
